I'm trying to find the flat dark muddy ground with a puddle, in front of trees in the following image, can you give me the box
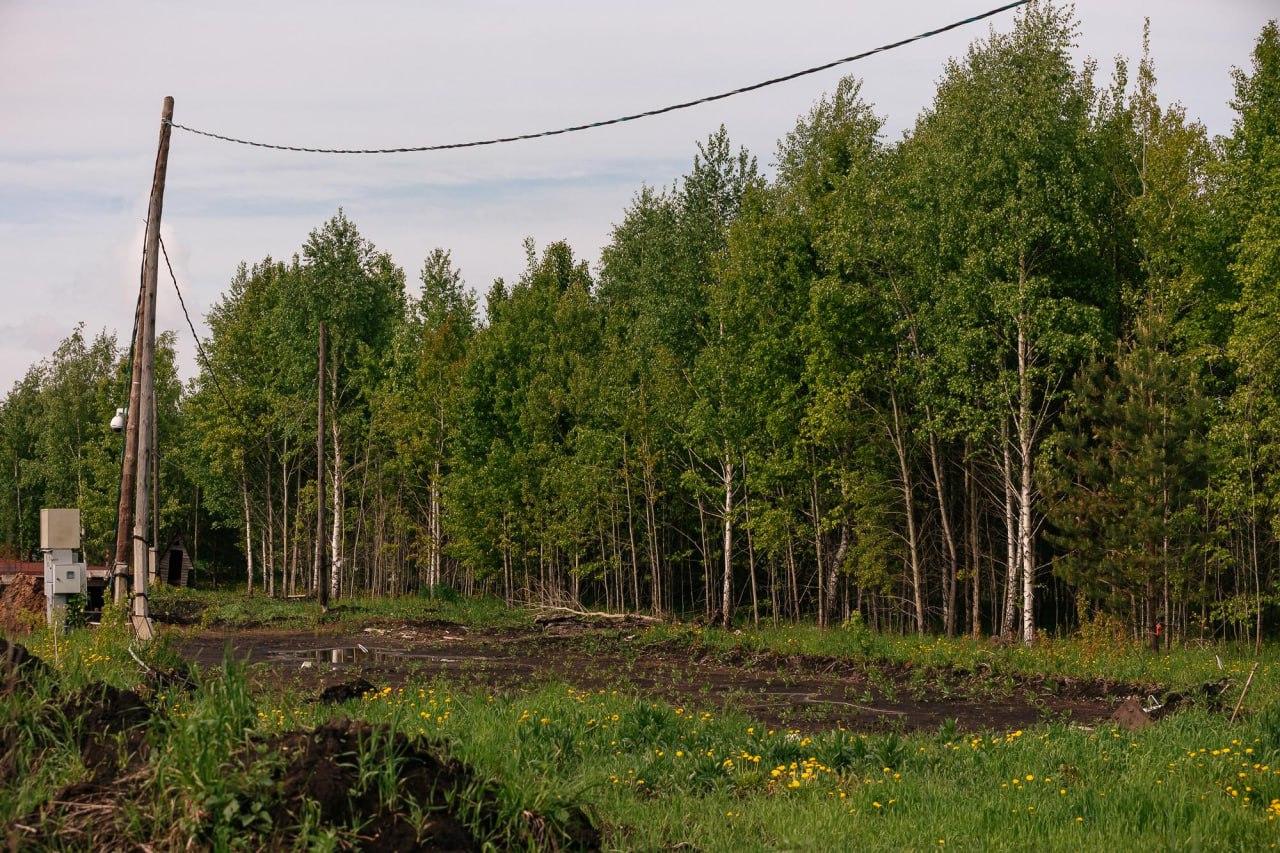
[178,622,1155,731]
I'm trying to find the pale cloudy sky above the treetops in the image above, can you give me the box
[0,0,1280,396]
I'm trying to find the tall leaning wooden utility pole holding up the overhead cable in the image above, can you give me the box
[129,97,173,642]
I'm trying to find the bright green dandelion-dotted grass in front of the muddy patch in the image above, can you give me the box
[264,683,1280,850]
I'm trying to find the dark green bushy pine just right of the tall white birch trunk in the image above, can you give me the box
[1041,308,1208,614]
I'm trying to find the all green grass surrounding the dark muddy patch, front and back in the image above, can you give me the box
[0,592,1280,850]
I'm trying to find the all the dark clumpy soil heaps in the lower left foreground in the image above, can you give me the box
[0,640,600,852]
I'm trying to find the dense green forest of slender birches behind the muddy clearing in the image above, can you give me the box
[0,4,1280,642]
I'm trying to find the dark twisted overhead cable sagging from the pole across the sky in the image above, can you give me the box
[169,0,1030,154]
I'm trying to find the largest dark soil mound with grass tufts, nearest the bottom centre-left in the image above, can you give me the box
[265,720,600,850]
